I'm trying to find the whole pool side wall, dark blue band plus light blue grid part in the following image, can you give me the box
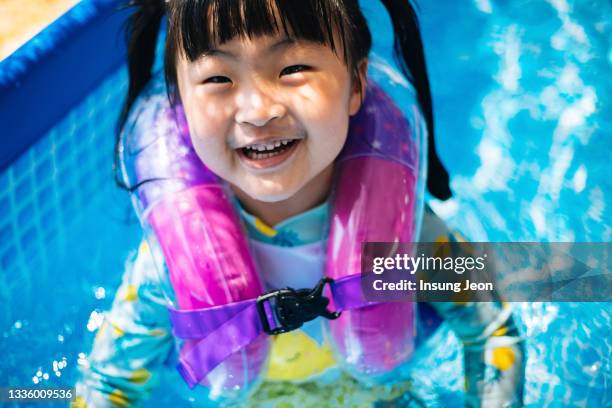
[0,0,134,317]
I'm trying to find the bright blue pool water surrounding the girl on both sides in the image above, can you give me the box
[0,0,612,407]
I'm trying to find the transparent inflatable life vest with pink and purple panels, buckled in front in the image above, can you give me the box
[119,62,427,400]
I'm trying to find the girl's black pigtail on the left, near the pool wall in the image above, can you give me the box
[113,0,165,190]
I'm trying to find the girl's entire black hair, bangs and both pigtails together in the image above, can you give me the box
[117,0,451,200]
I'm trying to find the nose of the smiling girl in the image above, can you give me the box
[235,85,287,127]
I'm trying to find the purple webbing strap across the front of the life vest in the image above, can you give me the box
[169,274,376,388]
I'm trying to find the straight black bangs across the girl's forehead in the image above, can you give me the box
[167,0,351,65]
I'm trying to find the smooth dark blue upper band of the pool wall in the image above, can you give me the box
[0,0,127,170]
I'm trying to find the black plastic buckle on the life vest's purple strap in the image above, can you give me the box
[257,277,340,334]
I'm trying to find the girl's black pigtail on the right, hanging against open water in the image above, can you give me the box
[381,0,452,200]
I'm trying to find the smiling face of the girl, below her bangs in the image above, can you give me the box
[177,35,366,202]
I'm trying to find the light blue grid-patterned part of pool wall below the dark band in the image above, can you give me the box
[0,68,127,272]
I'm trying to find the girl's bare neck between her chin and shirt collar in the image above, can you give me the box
[232,164,334,226]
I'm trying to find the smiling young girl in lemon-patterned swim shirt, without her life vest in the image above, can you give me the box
[76,0,524,407]
